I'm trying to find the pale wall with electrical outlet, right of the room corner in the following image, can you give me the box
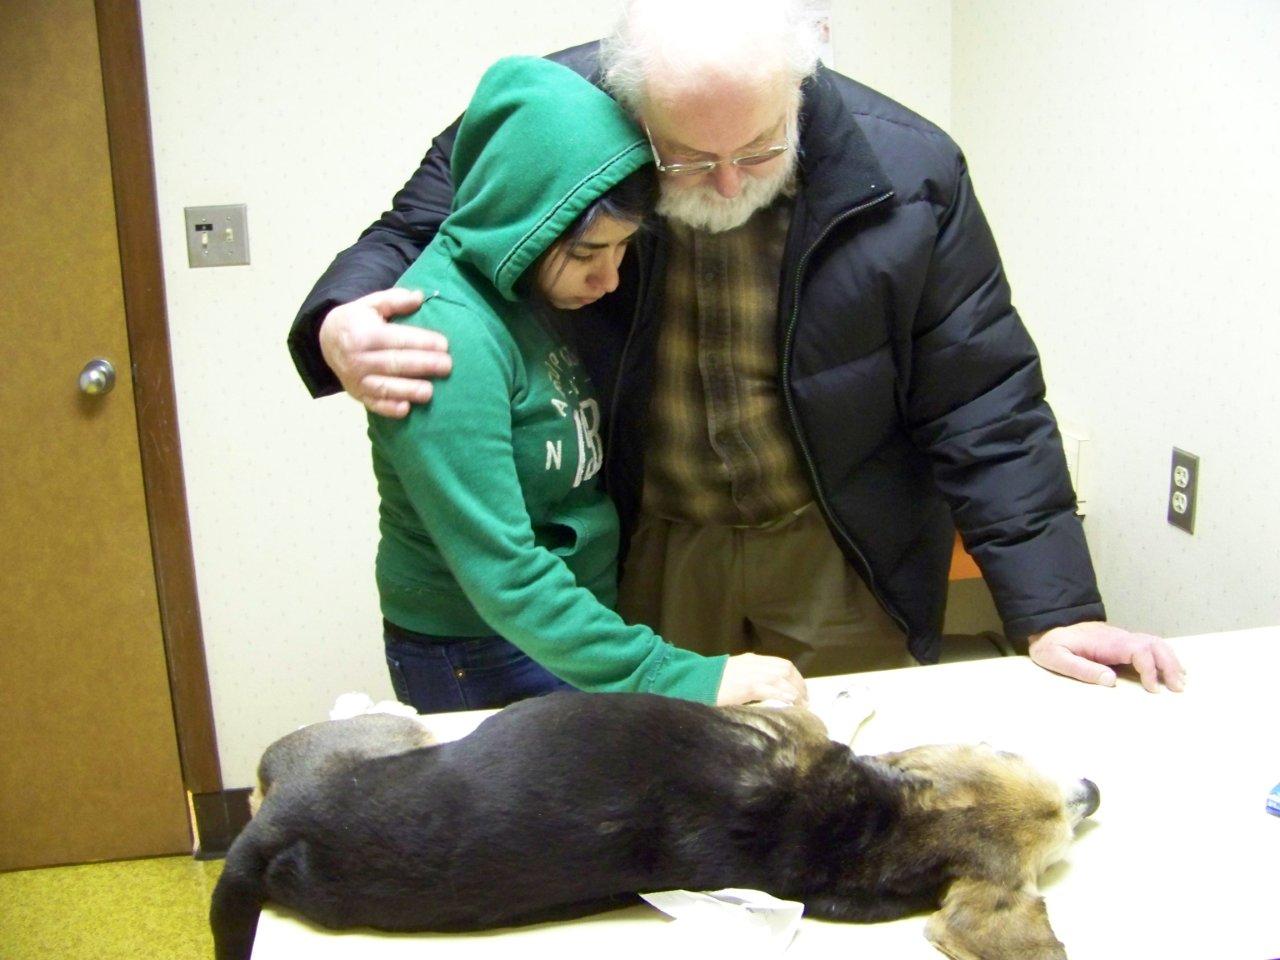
[952,0,1280,635]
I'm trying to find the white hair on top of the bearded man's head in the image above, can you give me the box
[600,0,829,114]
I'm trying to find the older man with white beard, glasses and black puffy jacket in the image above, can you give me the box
[291,0,1183,690]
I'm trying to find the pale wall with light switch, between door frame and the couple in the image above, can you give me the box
[142,0,612,786]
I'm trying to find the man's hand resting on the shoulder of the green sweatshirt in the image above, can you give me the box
[320,287,453,419]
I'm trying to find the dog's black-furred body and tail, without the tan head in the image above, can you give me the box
[211,694,962,960]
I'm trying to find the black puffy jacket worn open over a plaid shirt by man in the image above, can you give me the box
[289,44,1103,662]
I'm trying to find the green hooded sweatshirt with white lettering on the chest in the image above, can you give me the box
[369,58,726,703]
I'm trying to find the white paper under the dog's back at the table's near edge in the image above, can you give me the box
[640,888,804,956]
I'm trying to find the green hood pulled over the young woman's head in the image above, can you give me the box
[440,56,653,300]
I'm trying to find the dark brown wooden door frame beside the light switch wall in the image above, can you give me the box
[93,0,241,858]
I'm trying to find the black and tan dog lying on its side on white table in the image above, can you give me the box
[210,692,1098,960]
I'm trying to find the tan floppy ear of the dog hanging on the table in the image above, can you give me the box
[924,878,1066,960]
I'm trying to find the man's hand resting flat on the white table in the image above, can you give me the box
[1028,621,1187,694]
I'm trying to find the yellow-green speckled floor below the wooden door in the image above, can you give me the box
[0,856,223,960]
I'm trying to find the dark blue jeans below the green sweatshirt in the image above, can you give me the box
[383,630,573,713]
